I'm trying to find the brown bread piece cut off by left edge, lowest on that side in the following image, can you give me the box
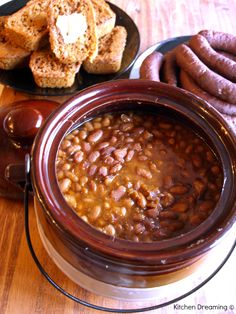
[0,42,30,70]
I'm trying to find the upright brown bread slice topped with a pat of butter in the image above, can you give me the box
[48,0,98,63]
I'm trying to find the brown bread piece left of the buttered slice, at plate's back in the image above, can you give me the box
[5,0,49,51]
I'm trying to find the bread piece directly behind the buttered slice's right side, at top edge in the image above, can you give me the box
[91,0,116,38]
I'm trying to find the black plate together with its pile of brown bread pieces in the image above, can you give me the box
[0,0,140,96]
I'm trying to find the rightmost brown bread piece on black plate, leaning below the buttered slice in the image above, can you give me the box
[83,26,127,74]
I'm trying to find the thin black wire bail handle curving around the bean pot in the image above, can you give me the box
[24,154,236,313]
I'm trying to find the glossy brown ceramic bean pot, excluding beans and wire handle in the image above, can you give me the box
[31,80,236,295]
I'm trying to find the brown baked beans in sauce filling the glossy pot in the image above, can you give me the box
[56,112,223,242]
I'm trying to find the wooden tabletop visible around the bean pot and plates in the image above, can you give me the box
[0,0,236,314]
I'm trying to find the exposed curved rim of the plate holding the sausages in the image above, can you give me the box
[129,35,191,79]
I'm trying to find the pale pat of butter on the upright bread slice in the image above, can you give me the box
[56,13,88,44]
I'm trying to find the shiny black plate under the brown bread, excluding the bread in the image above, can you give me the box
[0,0,140,96]
